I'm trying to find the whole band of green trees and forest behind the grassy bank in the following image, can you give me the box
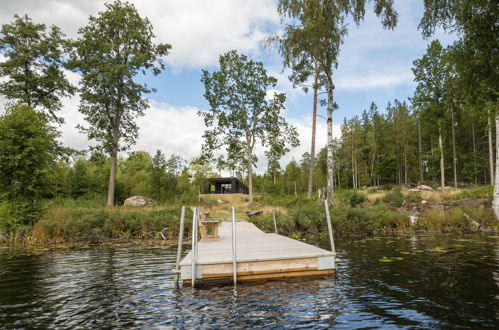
[0,0,499,238]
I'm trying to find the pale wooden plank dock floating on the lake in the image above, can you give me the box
[180,221,336,284]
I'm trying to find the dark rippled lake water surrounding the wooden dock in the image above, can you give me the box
[0,236,499,329]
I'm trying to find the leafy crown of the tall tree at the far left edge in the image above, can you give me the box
[0,15,75,122]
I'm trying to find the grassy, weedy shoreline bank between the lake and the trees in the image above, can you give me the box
[0,187,499,246]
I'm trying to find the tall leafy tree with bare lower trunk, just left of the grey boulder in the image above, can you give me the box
[70,0,171,205]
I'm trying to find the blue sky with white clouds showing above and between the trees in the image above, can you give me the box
[0,0,453,173]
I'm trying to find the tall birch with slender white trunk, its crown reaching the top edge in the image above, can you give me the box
[278,0,397,204]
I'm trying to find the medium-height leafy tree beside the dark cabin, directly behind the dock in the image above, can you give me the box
[200,51,298,203]
